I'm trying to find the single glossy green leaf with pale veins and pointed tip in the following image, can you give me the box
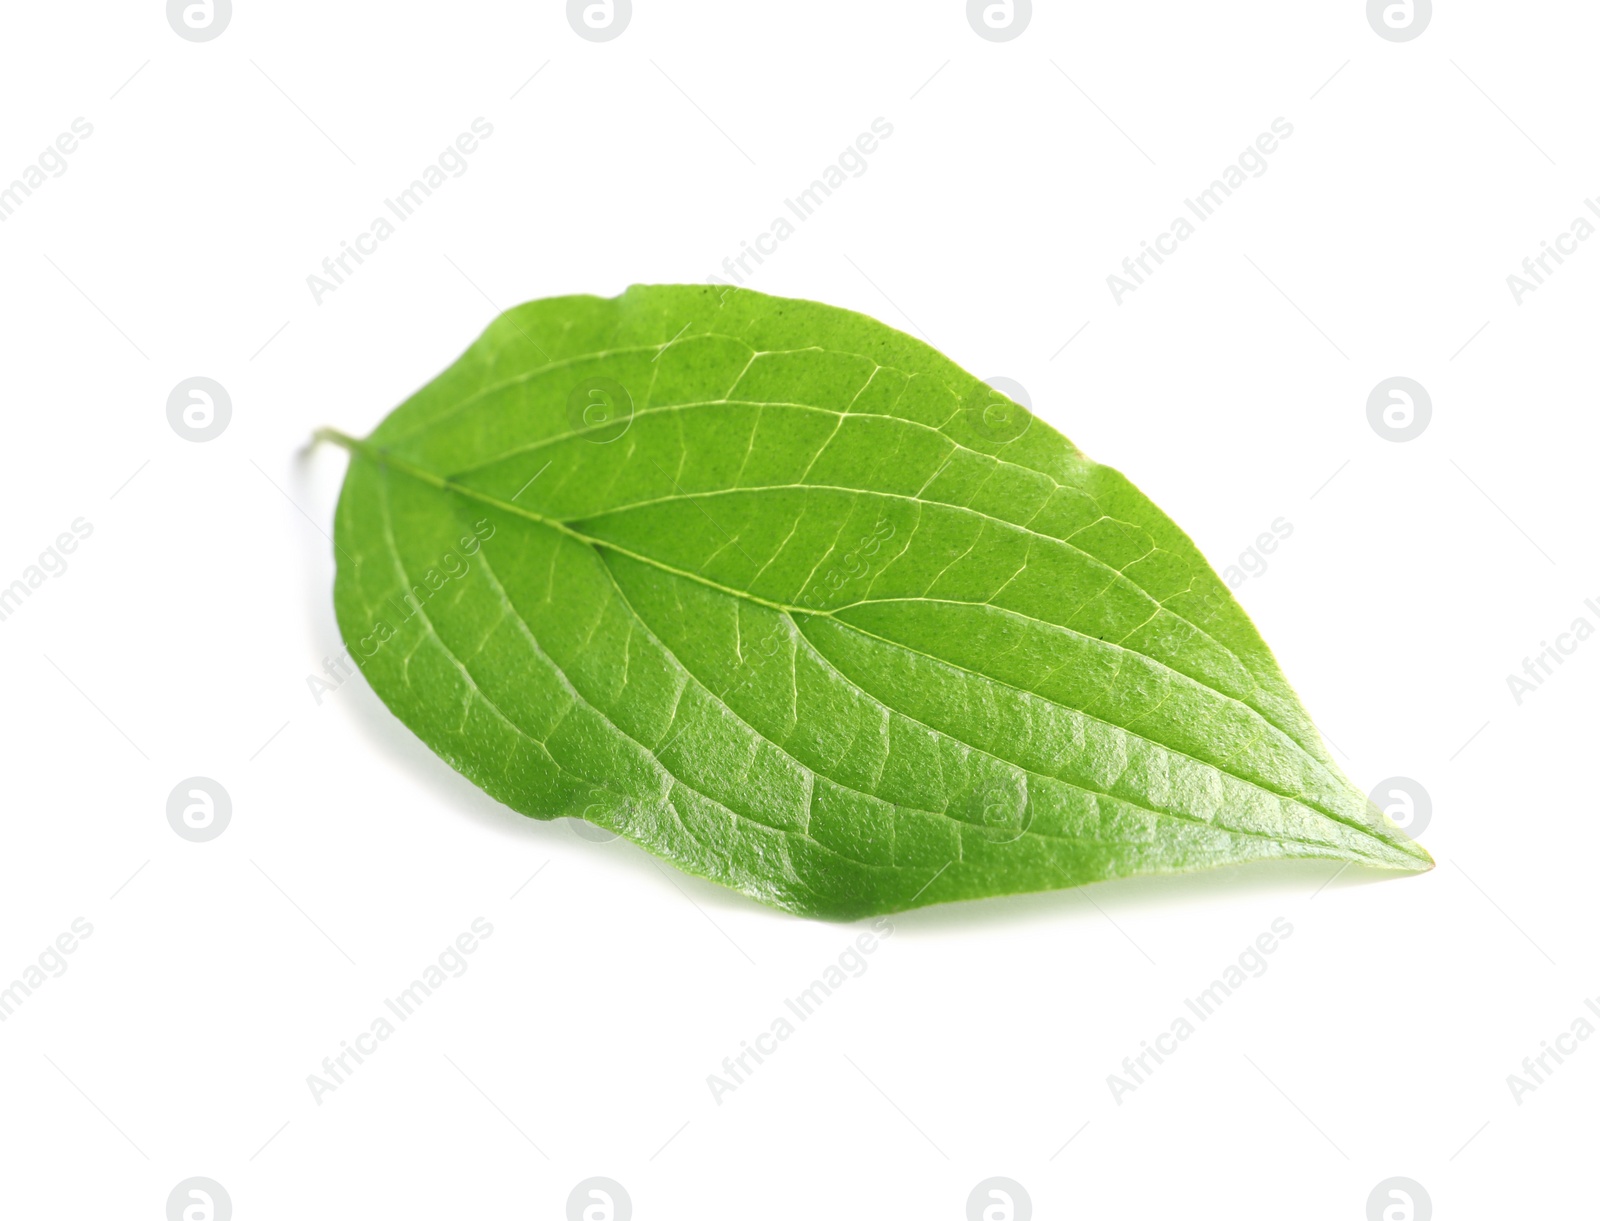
[325,286,1432,919]
